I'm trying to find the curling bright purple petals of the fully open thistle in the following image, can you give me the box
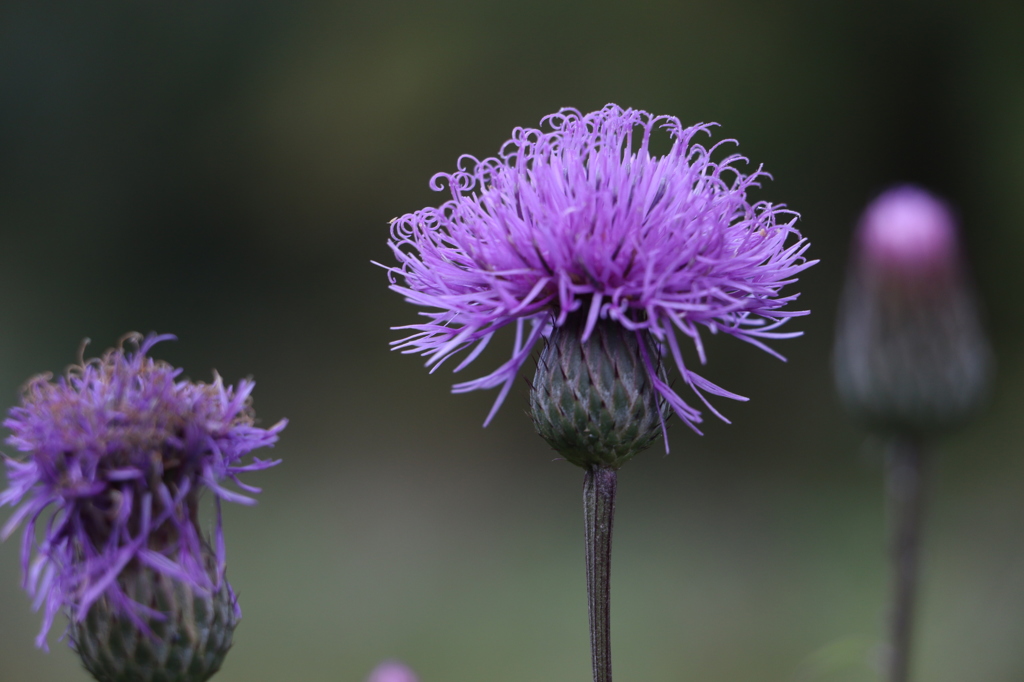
[389,104,813,428]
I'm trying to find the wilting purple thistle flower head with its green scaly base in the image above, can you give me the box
[0,334,286,682]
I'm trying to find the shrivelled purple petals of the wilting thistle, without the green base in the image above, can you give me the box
[0,334,287,647]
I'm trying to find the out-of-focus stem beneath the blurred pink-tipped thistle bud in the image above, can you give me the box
[886,437,925,682]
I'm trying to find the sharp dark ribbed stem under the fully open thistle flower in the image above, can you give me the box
[583,467,615,682]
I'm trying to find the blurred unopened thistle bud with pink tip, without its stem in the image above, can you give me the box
[835,186,991,432]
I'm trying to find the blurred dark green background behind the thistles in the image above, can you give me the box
[0,0,1024,682]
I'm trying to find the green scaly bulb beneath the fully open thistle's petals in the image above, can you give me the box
[529,312,662,469]
